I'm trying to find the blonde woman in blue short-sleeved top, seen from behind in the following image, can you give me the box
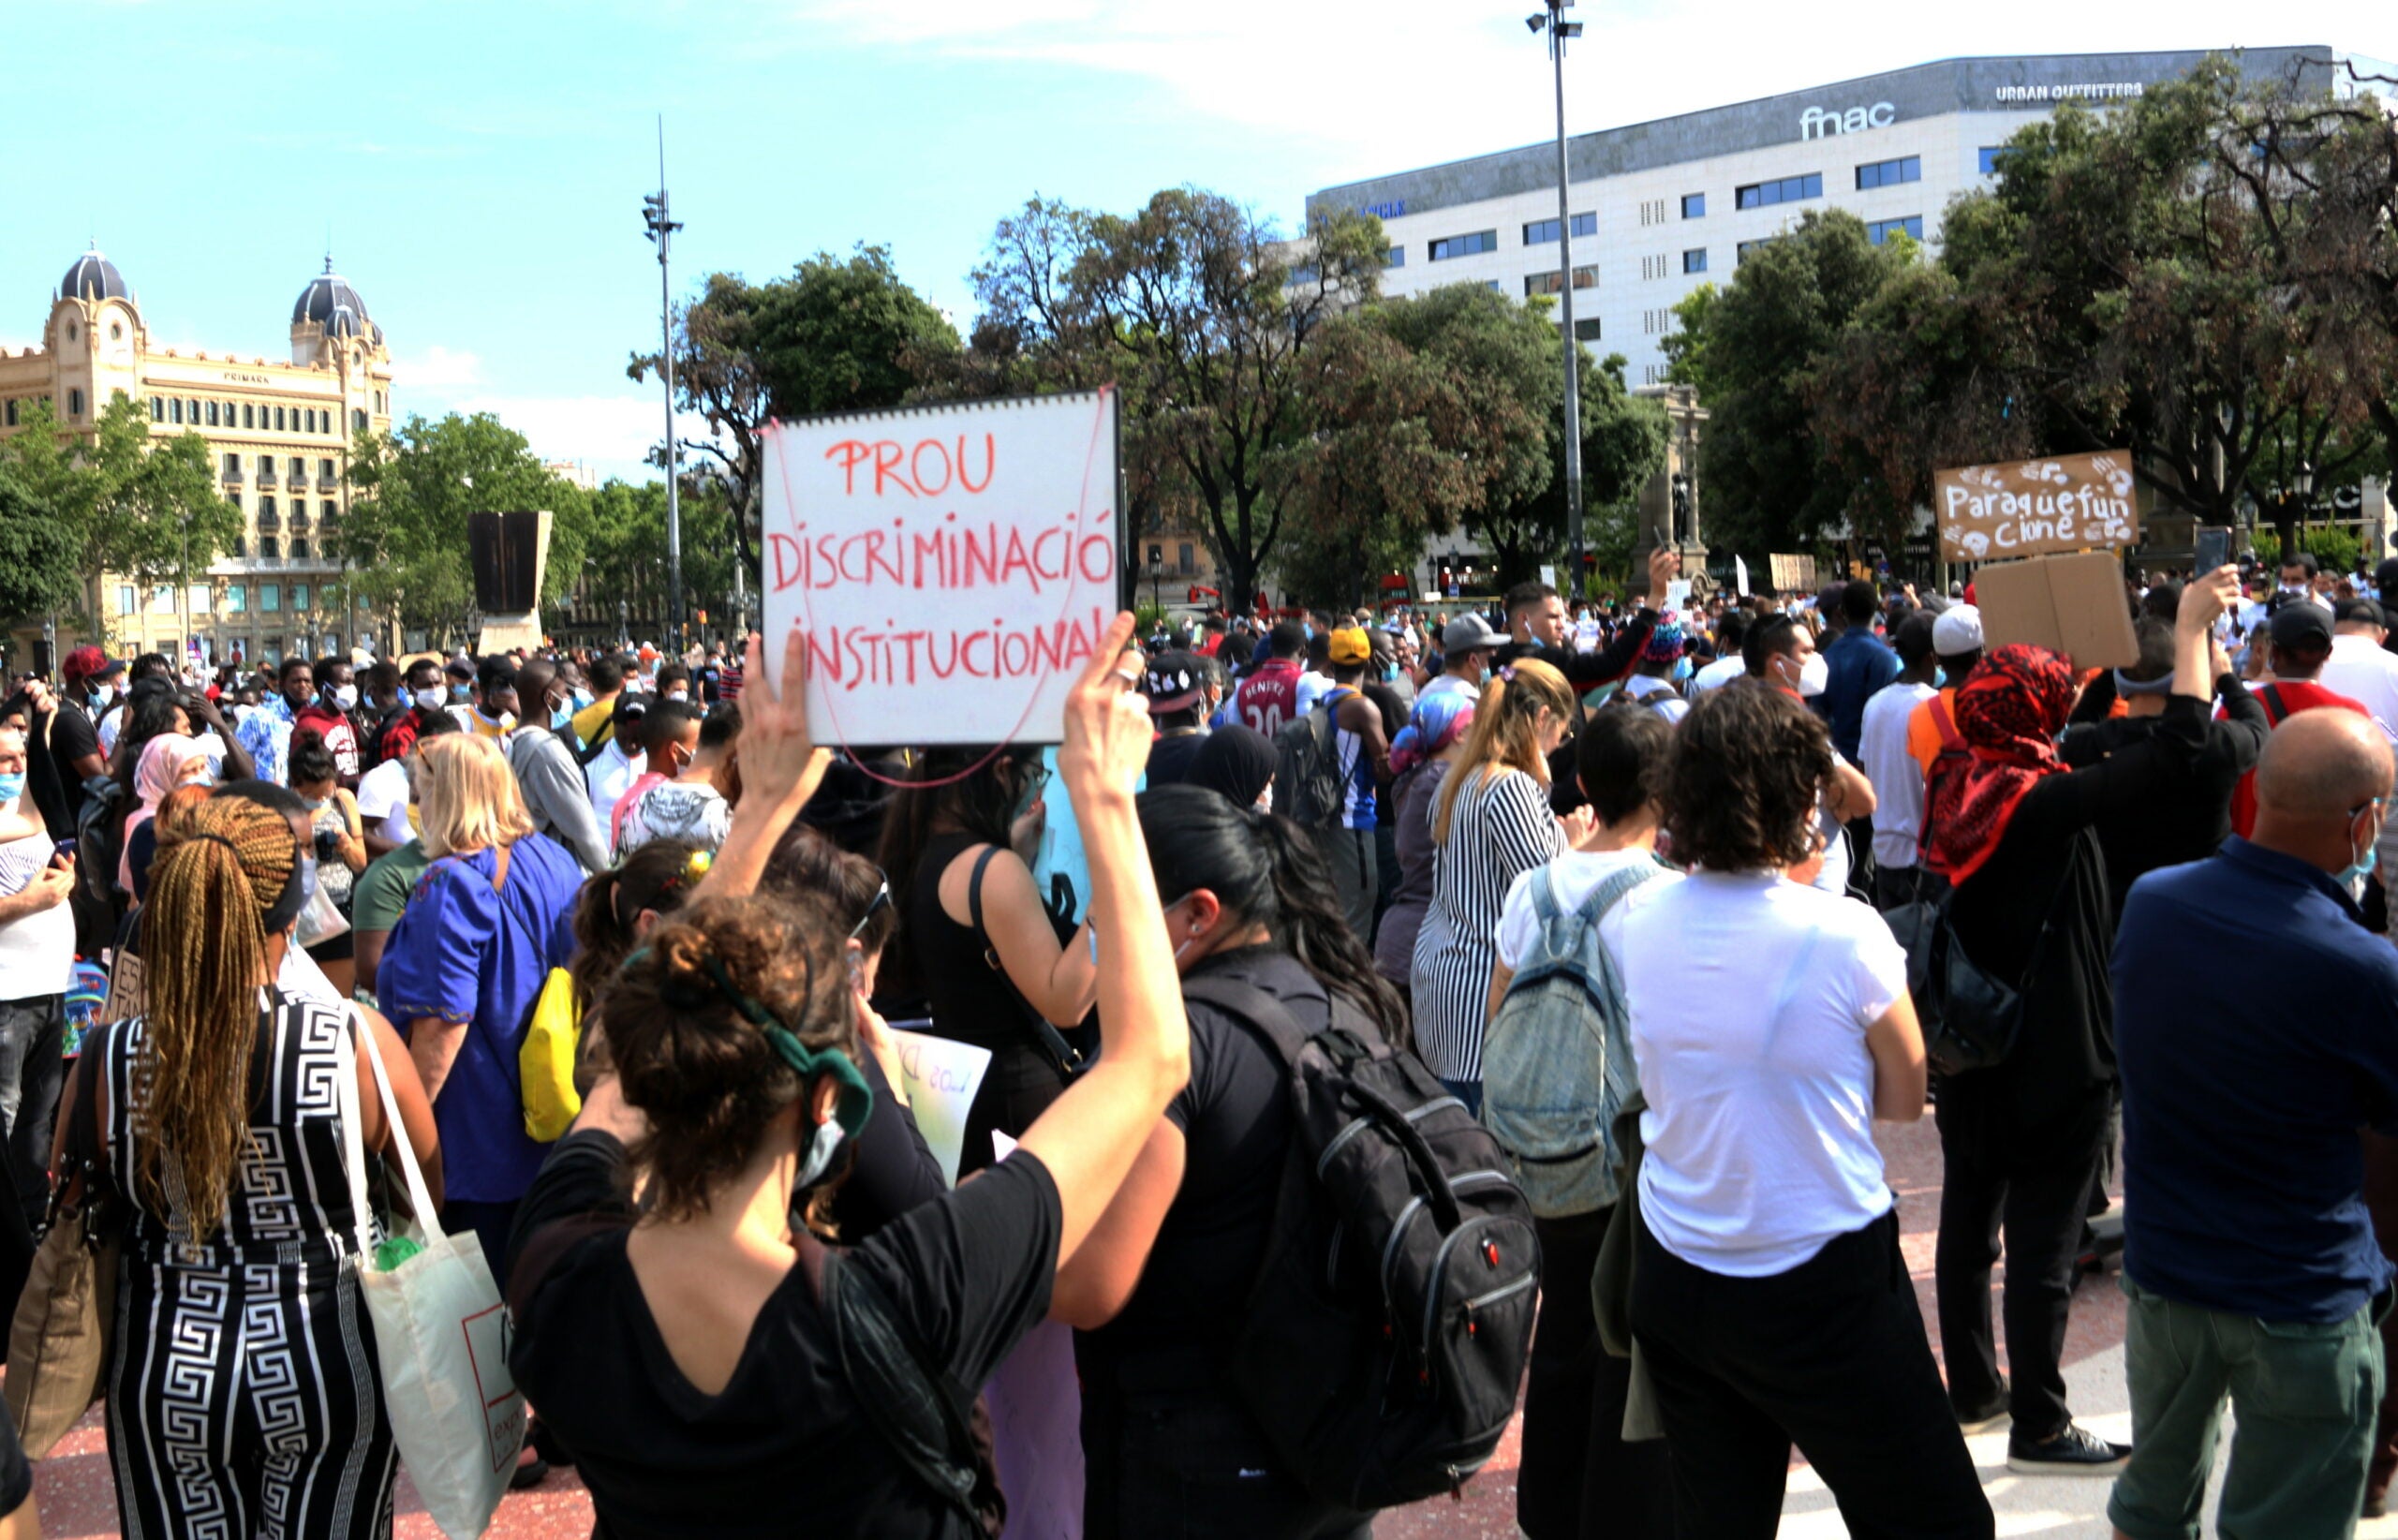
[374,734,583,1279]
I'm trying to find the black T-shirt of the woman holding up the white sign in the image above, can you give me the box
[509,1130,1062,1540]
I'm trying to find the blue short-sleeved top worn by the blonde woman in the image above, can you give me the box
[374,835,583,1204]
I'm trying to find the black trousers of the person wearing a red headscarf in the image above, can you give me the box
[1932,1103,2098,1444]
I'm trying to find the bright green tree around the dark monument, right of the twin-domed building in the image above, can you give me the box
[338,412,590,643]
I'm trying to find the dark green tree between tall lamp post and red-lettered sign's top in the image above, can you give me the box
[626,244,959,580]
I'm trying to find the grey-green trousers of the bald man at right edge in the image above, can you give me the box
[2108,1274,2389,1540]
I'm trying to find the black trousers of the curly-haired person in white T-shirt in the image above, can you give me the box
[1633,1211,1995,1540]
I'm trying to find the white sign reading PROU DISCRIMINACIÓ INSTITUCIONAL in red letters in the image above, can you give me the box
[762,389,1120,744]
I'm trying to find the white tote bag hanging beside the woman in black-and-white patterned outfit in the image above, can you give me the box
[341,1010,525,1540]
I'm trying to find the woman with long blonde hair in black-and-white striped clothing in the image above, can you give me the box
[1408,658,1590,1116]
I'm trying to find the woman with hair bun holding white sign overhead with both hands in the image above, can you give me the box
[509,615,1190,1540]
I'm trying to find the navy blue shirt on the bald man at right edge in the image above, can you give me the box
[2115,835,2398,1322]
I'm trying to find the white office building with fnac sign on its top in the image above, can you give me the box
[1307,46,2398,386]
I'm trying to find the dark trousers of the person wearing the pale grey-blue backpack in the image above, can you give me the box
[1516,1199,1674,1540]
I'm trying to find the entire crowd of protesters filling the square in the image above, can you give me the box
[0,541,2398,1540]
